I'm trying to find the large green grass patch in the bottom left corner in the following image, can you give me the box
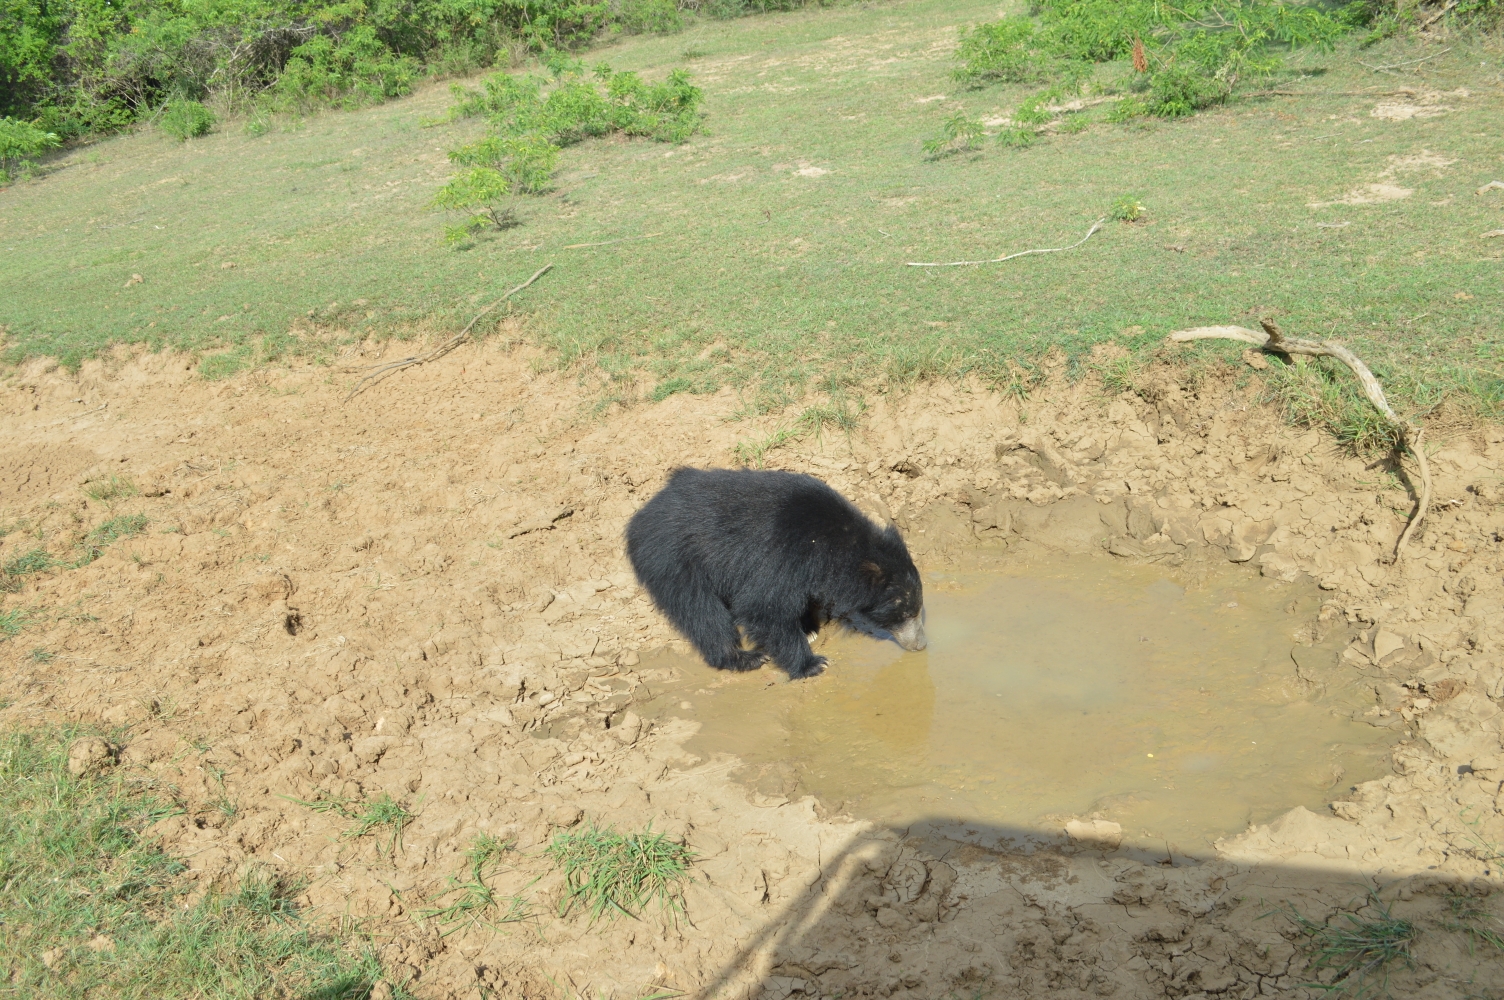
[0,728,379,1000]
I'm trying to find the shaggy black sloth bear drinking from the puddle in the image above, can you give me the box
[627,469,925,678]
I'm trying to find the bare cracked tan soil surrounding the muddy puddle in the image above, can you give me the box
[0,339,1504,1000]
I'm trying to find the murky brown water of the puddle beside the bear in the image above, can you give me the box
[634,556,1396,854]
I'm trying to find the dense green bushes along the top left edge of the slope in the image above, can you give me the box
[0,0,776,138]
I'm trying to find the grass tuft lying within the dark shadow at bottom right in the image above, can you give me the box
[1286,889,1420,997]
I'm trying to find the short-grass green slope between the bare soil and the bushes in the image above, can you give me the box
[0,0,1504,418]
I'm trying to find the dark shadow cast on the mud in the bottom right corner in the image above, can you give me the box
[699,809,1504,1000]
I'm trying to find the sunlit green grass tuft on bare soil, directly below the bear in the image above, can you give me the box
[544,823,693,922]
